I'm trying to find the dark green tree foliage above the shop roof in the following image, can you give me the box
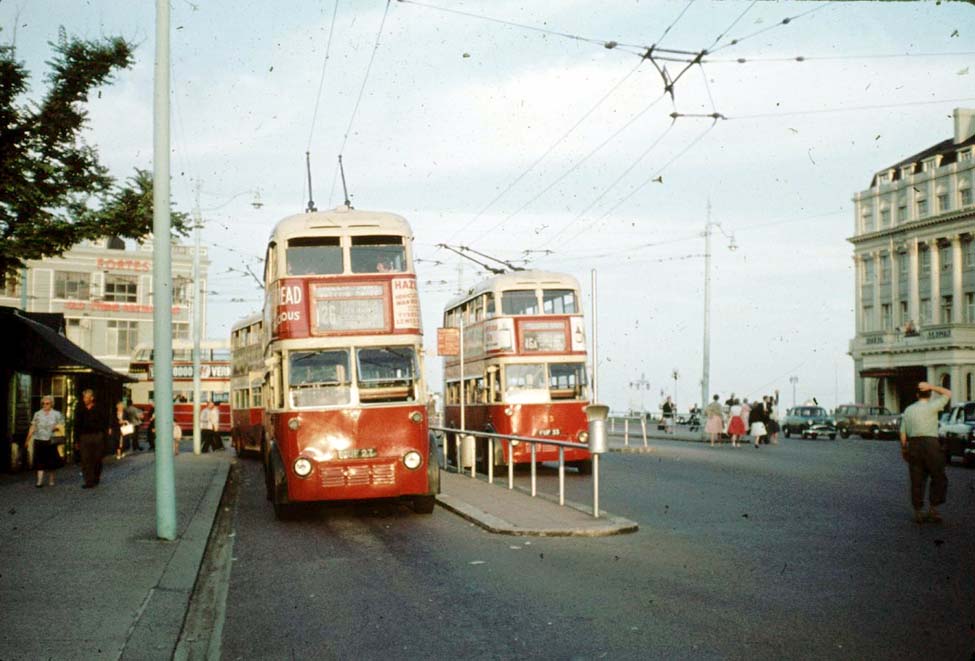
[0,33,189,284]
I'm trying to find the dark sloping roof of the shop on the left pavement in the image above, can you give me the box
[0,307,134,381]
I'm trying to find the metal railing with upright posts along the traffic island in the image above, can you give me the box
[430,426,599,518]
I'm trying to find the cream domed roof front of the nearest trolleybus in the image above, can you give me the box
[269,206,413,243]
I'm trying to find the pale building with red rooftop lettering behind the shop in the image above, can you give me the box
[0,238,209,374]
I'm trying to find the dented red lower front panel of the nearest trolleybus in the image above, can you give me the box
[269,405,430,502]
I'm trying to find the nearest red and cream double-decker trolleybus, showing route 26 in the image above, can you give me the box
[264,207,440,517]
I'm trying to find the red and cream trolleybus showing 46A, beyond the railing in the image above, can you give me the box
[444,271,592,474]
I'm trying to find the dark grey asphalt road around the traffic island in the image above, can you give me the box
[222,438,975,659]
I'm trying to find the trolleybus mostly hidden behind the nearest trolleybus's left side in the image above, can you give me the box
[230,313,264,456]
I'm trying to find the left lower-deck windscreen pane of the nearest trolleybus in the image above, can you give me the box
[288,349,349,407]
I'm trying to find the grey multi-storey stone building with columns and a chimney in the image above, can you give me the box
[849,108,975,411]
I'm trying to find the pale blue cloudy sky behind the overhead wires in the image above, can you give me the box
[0,0,975,408]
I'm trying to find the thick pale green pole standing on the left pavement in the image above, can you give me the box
[152,0,176,540]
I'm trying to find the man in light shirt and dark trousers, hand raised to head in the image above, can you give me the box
[900,381,951,523]
